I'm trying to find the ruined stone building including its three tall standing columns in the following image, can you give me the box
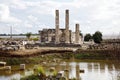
[39,10,82,45]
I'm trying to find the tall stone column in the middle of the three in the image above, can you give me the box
[65,10,70,43]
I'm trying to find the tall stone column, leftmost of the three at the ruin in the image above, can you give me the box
[55,10,59,44]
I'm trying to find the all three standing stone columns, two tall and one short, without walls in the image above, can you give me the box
[55,10,80,44]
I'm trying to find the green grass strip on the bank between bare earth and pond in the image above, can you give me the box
[0,50,120,65]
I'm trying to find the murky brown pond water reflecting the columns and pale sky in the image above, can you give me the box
[0,60,120,80]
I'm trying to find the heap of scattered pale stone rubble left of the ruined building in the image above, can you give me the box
[0,40,38,51]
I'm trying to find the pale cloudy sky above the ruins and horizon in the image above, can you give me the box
[0,0,120,34]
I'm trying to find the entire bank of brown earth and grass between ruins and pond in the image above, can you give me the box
[0,48,120,65]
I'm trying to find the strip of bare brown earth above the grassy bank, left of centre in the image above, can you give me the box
[0,47,76,57]
